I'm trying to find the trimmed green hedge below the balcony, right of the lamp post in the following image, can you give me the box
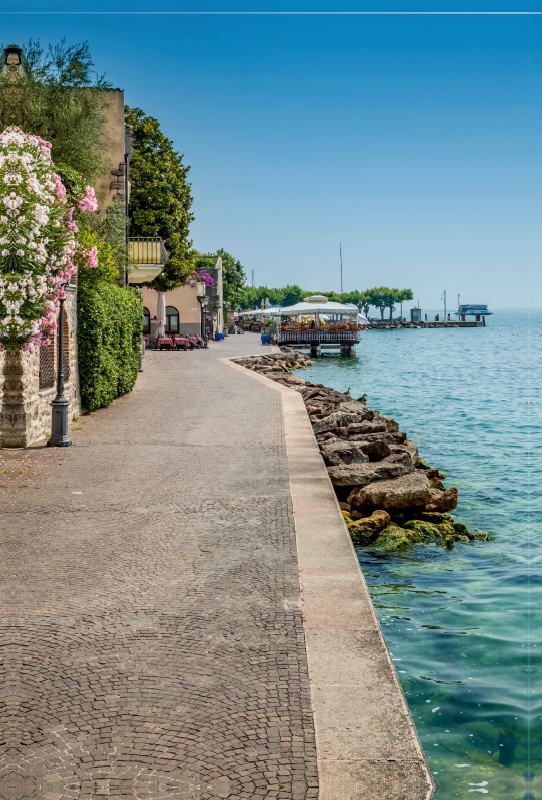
[77,283,143,411]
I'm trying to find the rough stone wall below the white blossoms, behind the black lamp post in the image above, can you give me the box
[0,287,81,447]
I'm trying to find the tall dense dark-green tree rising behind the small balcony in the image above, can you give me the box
[125,106,194,292]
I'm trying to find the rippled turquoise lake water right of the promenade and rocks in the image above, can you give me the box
[301,313,542,800]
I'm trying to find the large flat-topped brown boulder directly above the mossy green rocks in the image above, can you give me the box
[347,472,431,511]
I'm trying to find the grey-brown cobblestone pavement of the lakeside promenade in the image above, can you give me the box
[0,334,318,800]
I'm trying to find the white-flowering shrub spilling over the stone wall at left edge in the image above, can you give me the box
[0,128,77,349]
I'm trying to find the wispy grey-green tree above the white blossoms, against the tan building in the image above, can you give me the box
[0,39,111,183]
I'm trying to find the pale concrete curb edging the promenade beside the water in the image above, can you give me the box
[219,358,435,800]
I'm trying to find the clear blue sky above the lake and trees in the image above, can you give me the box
[0,0,542,308]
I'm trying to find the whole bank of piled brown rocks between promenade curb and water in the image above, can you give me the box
[236,350,491,550]
